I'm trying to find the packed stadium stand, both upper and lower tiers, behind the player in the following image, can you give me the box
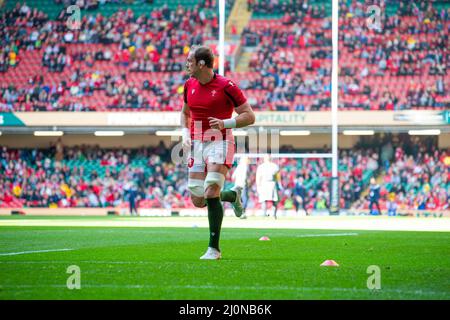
[0,0,450,215]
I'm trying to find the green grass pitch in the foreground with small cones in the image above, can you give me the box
[0,217,450,300]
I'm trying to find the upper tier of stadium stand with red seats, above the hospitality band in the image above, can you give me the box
[0,0,450,112]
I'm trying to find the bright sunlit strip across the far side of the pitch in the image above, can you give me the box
[0,216,450,231]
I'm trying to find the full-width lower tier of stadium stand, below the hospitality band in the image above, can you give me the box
[0,135,450,211]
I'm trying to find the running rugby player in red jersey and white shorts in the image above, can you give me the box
[181,46,255,260]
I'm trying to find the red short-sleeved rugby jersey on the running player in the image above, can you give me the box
[184,73,247,141]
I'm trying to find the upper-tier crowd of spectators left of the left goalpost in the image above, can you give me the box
[0,1,220,111]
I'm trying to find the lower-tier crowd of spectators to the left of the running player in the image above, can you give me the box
[0,144,189,207]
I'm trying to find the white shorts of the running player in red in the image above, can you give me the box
[188,140,235,172]
